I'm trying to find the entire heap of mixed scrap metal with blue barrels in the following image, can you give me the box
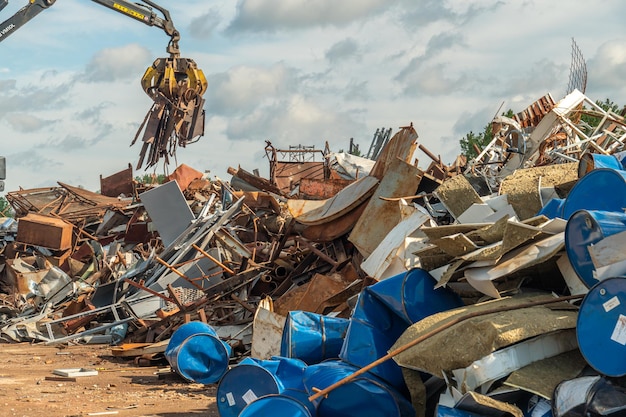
[0,90,626,417]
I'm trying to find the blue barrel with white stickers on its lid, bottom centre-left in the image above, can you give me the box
[216,357,306,417]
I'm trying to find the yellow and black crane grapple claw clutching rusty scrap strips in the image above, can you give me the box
[131,55,207,169]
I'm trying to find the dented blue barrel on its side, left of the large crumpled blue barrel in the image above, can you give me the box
[280,311,350,365]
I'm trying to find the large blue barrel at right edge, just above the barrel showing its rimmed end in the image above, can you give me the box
[563,168,626,220]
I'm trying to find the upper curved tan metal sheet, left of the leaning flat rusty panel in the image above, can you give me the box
[287,177,378,226]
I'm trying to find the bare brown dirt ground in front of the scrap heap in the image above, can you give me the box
[0,343,219,417]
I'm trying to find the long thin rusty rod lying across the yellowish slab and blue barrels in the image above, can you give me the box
[309,295,584,402]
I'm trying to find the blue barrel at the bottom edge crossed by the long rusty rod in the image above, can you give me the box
[304,360,415,417]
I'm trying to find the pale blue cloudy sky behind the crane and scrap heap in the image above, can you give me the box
[0,0,626,192]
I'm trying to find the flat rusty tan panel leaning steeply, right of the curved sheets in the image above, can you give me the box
[348,159,422,257]
